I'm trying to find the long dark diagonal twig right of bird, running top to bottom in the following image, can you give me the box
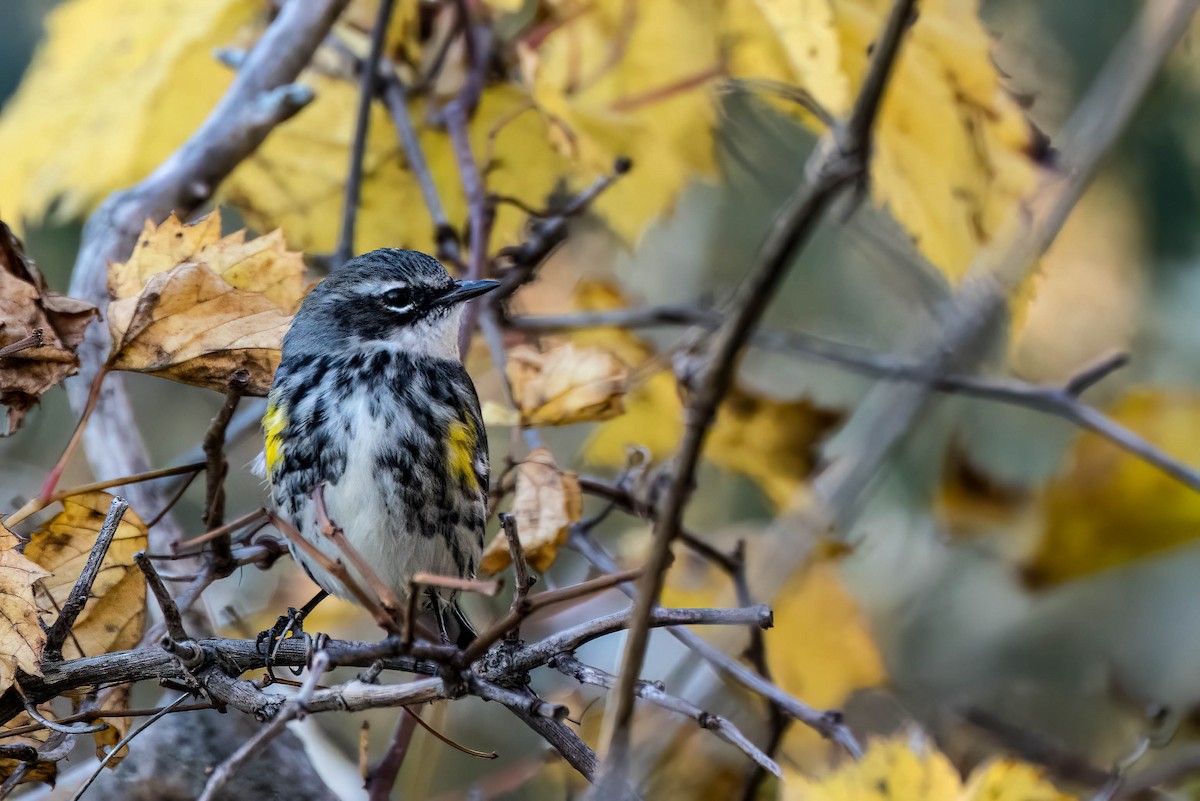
[595,0,914,781]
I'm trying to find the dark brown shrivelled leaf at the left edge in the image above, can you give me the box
[0,222,96,433]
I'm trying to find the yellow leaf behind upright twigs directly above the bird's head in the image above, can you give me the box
[222,73,570,253]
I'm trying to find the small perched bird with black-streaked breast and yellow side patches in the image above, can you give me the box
[263,248,499,642]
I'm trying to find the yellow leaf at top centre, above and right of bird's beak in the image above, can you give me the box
[522,0,722,242]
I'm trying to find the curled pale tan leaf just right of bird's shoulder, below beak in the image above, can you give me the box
[508,343,629,426]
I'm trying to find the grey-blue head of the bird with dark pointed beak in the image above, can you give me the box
[283,248,499,359]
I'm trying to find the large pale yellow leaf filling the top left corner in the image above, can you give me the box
[0,0,258,223]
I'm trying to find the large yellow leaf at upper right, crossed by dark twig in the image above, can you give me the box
[726,0,1038,279]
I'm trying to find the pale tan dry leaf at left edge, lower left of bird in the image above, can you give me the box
[0,526,49,692]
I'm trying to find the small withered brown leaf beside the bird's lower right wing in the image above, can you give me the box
[480,447,583,573]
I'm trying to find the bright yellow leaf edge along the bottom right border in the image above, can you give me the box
[781,736,1074,801]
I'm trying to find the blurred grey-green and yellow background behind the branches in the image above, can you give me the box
[0,0,1200,799]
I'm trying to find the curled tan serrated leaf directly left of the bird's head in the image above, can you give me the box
[108,212,306,395]
